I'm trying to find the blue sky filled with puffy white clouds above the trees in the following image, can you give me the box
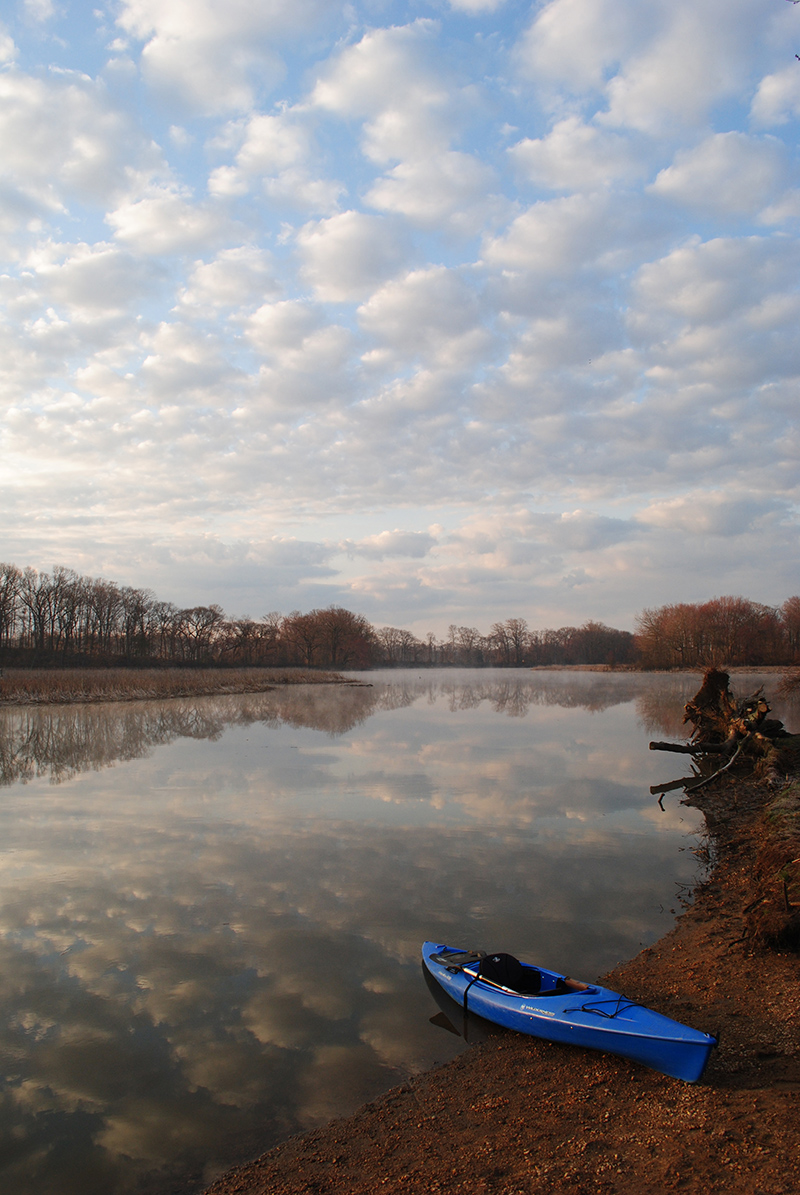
[0,0,800,635]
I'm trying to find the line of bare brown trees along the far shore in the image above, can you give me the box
[0,564,800,668]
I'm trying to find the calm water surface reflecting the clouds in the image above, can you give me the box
[0,670,790,1195]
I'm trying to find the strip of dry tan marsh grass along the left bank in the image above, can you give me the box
[0,668,353,705]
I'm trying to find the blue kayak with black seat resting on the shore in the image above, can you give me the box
[422,942,716,1083]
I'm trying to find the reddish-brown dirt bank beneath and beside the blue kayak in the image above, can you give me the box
[208,769,800,1195]
